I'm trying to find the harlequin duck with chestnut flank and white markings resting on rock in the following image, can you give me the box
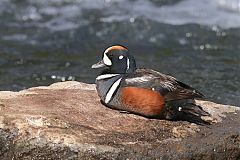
[92,45,209,120]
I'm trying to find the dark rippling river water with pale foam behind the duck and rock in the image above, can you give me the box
[0,0,240,105]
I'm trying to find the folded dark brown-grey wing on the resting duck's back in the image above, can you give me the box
[125,69,204,101]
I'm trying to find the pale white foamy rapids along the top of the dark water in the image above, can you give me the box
[0,0,240,31]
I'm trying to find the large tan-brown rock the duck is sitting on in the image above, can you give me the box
[0,81,240,160]
